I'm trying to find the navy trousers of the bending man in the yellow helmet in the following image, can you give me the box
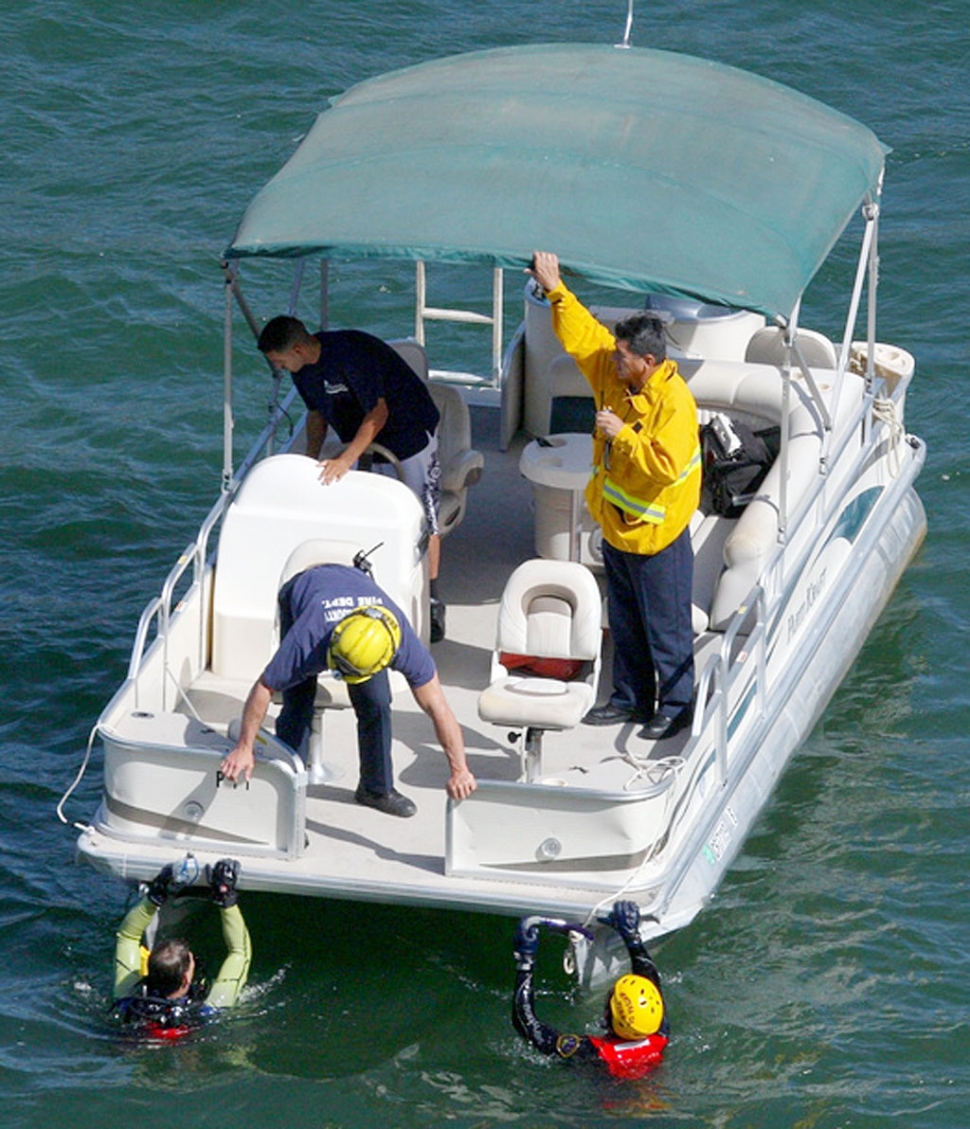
[277,585,394,795]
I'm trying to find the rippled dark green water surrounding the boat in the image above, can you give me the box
[0,0,970,1129]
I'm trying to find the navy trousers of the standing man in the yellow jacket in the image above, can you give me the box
[603,530,693,718]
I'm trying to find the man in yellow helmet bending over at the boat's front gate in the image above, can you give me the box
[220,565,475,816]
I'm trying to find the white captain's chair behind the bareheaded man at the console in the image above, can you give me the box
[378,338,484,537]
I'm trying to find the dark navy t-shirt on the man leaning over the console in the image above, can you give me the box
[292,330,438,458]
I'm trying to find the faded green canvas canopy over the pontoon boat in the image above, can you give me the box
[227,44,888,316]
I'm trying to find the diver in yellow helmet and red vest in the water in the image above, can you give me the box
[512,902,670,1078]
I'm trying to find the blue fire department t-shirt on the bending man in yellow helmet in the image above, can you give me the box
[262,565,435,690]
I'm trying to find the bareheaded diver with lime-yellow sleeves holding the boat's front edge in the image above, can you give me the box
[112,858,253,1039]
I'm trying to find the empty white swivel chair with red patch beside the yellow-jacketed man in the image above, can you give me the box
[479,560,602,780]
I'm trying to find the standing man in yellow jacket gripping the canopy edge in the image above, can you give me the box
[531,251,701,741]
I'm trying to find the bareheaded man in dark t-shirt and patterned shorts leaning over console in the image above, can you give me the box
[256,315,453,642]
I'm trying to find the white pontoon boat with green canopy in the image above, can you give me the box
[64,45,925,979]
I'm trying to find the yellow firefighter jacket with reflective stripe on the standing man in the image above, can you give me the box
[547,282,701,557]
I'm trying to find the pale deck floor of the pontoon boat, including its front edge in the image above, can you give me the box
[84,409,719,913]
